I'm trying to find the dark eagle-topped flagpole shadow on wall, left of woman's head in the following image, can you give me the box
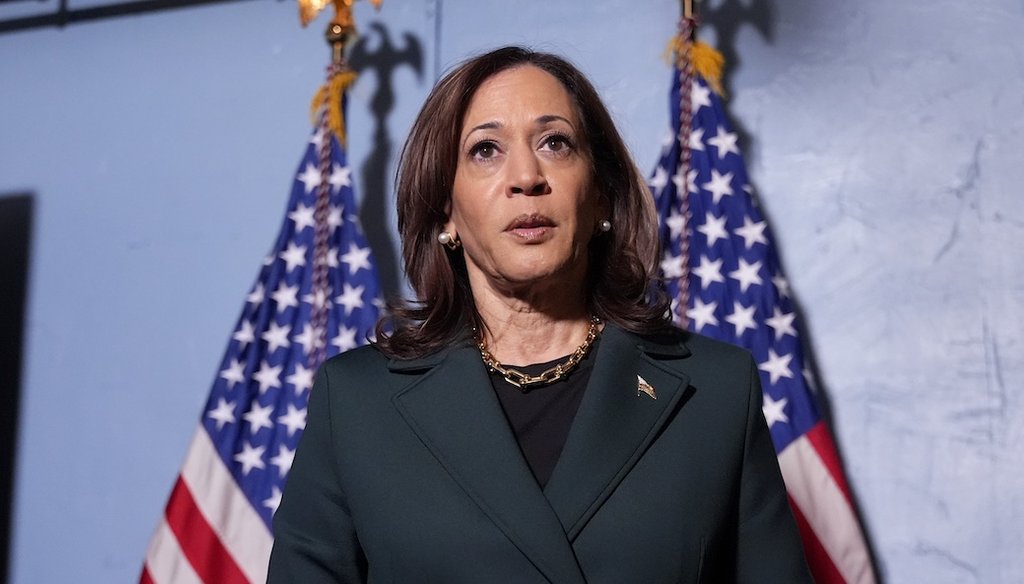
[349,23,423,297]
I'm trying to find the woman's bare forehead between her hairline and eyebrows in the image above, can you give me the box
[463,65,578,129]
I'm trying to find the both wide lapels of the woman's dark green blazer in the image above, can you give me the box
[388,323,689,573]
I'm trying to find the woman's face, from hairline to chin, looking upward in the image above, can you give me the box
[445,66,607,289]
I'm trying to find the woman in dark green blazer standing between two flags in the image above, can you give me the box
[269,47,810,584]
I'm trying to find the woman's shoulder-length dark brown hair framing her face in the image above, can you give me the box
[377,47,669,359]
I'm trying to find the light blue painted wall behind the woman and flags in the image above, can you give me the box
[0,0,1024,584]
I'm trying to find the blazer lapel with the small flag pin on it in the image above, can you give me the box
[544,324,689,541]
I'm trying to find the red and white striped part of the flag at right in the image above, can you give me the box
[778,422,874,584]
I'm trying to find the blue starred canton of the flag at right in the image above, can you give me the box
[649,71,820,452]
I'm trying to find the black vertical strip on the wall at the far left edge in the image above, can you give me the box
[0,195,33,583]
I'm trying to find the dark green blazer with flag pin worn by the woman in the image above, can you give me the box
[268,324,811,584]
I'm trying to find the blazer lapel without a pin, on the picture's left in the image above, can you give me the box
[392,345,585,584]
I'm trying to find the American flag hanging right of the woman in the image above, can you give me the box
[650,49,874,583]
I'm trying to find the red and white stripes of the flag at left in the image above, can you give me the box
[140,426,273,584]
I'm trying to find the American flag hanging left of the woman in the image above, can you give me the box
[140,119,382,584]
